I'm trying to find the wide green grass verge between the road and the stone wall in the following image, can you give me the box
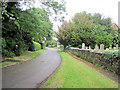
[43,51,118,88]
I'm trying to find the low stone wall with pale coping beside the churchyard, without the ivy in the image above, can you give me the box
[67,48,120,75]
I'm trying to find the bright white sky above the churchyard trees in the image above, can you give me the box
[53,0,120,30]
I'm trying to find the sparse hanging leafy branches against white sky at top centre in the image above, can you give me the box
[41,0,66,22]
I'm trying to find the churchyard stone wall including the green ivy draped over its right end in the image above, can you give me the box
[68,49,120,75]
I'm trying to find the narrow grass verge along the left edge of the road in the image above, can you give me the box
[0,50,43,66]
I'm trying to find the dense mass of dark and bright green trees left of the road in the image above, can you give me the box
[2,0,63,57]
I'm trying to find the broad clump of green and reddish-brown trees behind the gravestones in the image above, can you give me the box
[56,12,118,49]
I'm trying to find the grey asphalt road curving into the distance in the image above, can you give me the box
[2,49,61,88]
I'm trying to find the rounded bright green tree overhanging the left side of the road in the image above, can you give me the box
[20,8,53,46]
